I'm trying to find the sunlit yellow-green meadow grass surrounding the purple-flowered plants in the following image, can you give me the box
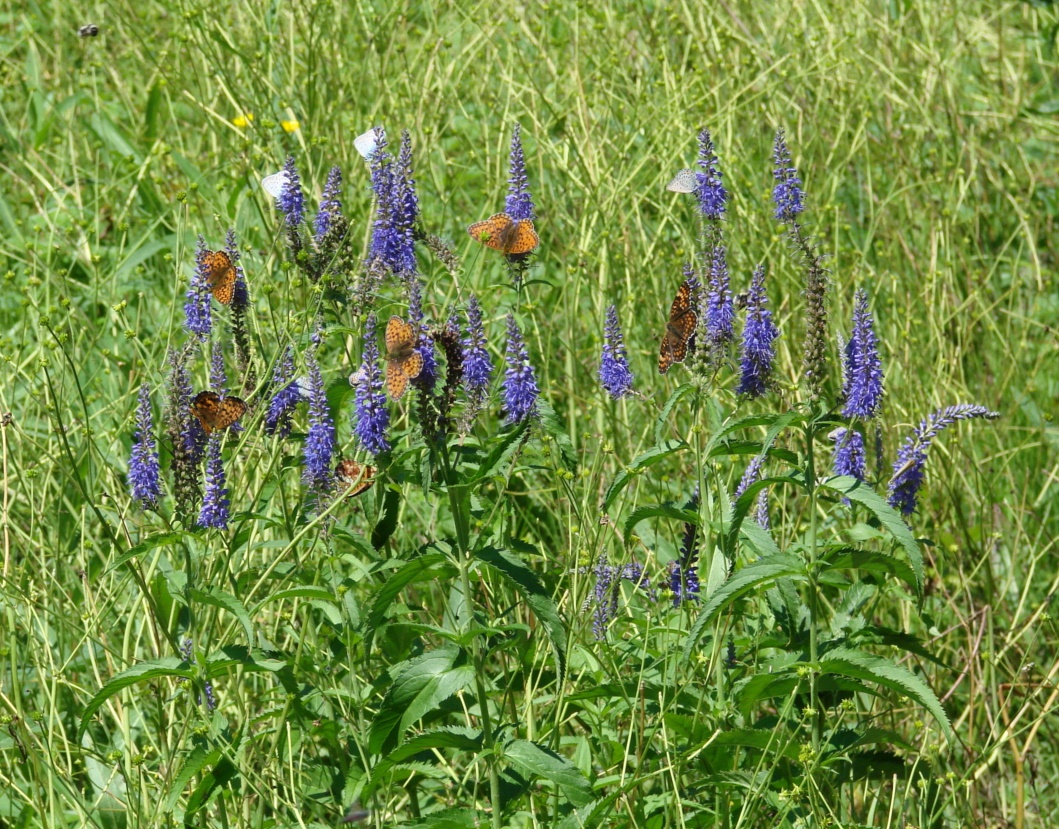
[0,0,1059,829]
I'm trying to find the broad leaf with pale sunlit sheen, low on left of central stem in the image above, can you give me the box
[367,645,472,754]
